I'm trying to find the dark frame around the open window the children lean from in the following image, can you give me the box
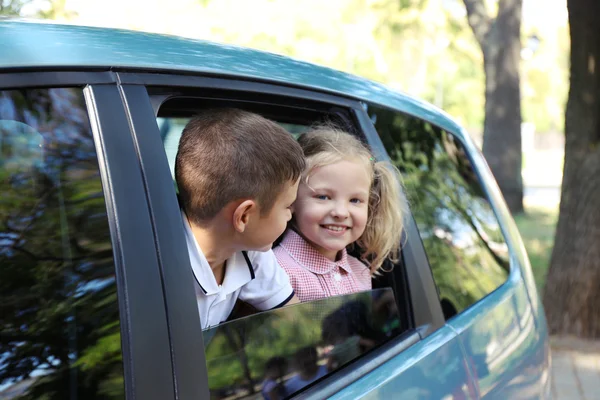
[117,71,444,399]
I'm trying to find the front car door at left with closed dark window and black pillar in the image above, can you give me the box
[0,71,175,400]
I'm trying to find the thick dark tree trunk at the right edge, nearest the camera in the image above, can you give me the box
[544,0,600,338]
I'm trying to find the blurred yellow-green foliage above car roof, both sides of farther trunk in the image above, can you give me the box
[19,0,569,132]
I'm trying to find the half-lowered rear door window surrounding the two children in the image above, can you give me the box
[149,94,412,399]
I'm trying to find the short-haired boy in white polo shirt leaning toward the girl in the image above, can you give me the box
[175,109,305,329]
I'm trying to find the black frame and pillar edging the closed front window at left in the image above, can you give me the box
[0,71,175,400]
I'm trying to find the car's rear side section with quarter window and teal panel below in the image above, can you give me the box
[366,101,549,399]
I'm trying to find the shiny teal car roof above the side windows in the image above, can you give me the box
[0,20,464,136]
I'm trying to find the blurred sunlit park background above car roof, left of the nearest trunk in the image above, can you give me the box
[0,0,594,336]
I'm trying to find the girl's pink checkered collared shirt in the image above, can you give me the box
[273,230,371,301]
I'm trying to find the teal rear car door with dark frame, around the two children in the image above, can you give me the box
[119,73,476,399]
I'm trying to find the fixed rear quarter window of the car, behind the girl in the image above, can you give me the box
[368,106,509,318]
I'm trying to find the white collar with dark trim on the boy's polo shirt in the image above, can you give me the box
[181,210,254,295]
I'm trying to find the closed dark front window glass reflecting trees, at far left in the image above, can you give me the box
[0,89,125,400]
